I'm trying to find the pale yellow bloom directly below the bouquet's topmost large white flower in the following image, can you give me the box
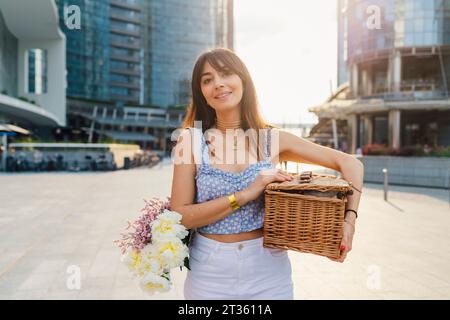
[155,238,189,269]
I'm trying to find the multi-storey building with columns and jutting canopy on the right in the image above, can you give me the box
[310,0,450,152]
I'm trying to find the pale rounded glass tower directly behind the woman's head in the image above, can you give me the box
[149,0,233,106]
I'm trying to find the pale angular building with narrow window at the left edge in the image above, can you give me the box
[0,0,66,138]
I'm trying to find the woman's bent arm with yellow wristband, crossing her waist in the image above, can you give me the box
[170,131,252,229]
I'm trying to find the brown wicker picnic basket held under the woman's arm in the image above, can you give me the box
[264,173,352,258]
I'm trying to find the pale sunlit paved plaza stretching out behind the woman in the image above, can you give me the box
[0,160,450,299]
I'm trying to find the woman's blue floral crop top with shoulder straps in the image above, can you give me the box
[194,129,274,234]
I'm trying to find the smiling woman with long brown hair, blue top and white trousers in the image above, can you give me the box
[171,49,363,299]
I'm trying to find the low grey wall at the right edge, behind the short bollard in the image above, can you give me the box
[359,156,450,188]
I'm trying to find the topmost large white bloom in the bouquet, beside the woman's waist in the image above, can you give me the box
[151,210,189,241]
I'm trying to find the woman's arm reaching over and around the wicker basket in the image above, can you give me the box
[279,130,364,223]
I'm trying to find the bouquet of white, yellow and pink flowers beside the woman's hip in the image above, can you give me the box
[115,198,190,294]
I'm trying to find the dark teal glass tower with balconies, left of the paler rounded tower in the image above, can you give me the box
[57,0,144,103]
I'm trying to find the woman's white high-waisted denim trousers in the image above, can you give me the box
[184,232,293,300]
